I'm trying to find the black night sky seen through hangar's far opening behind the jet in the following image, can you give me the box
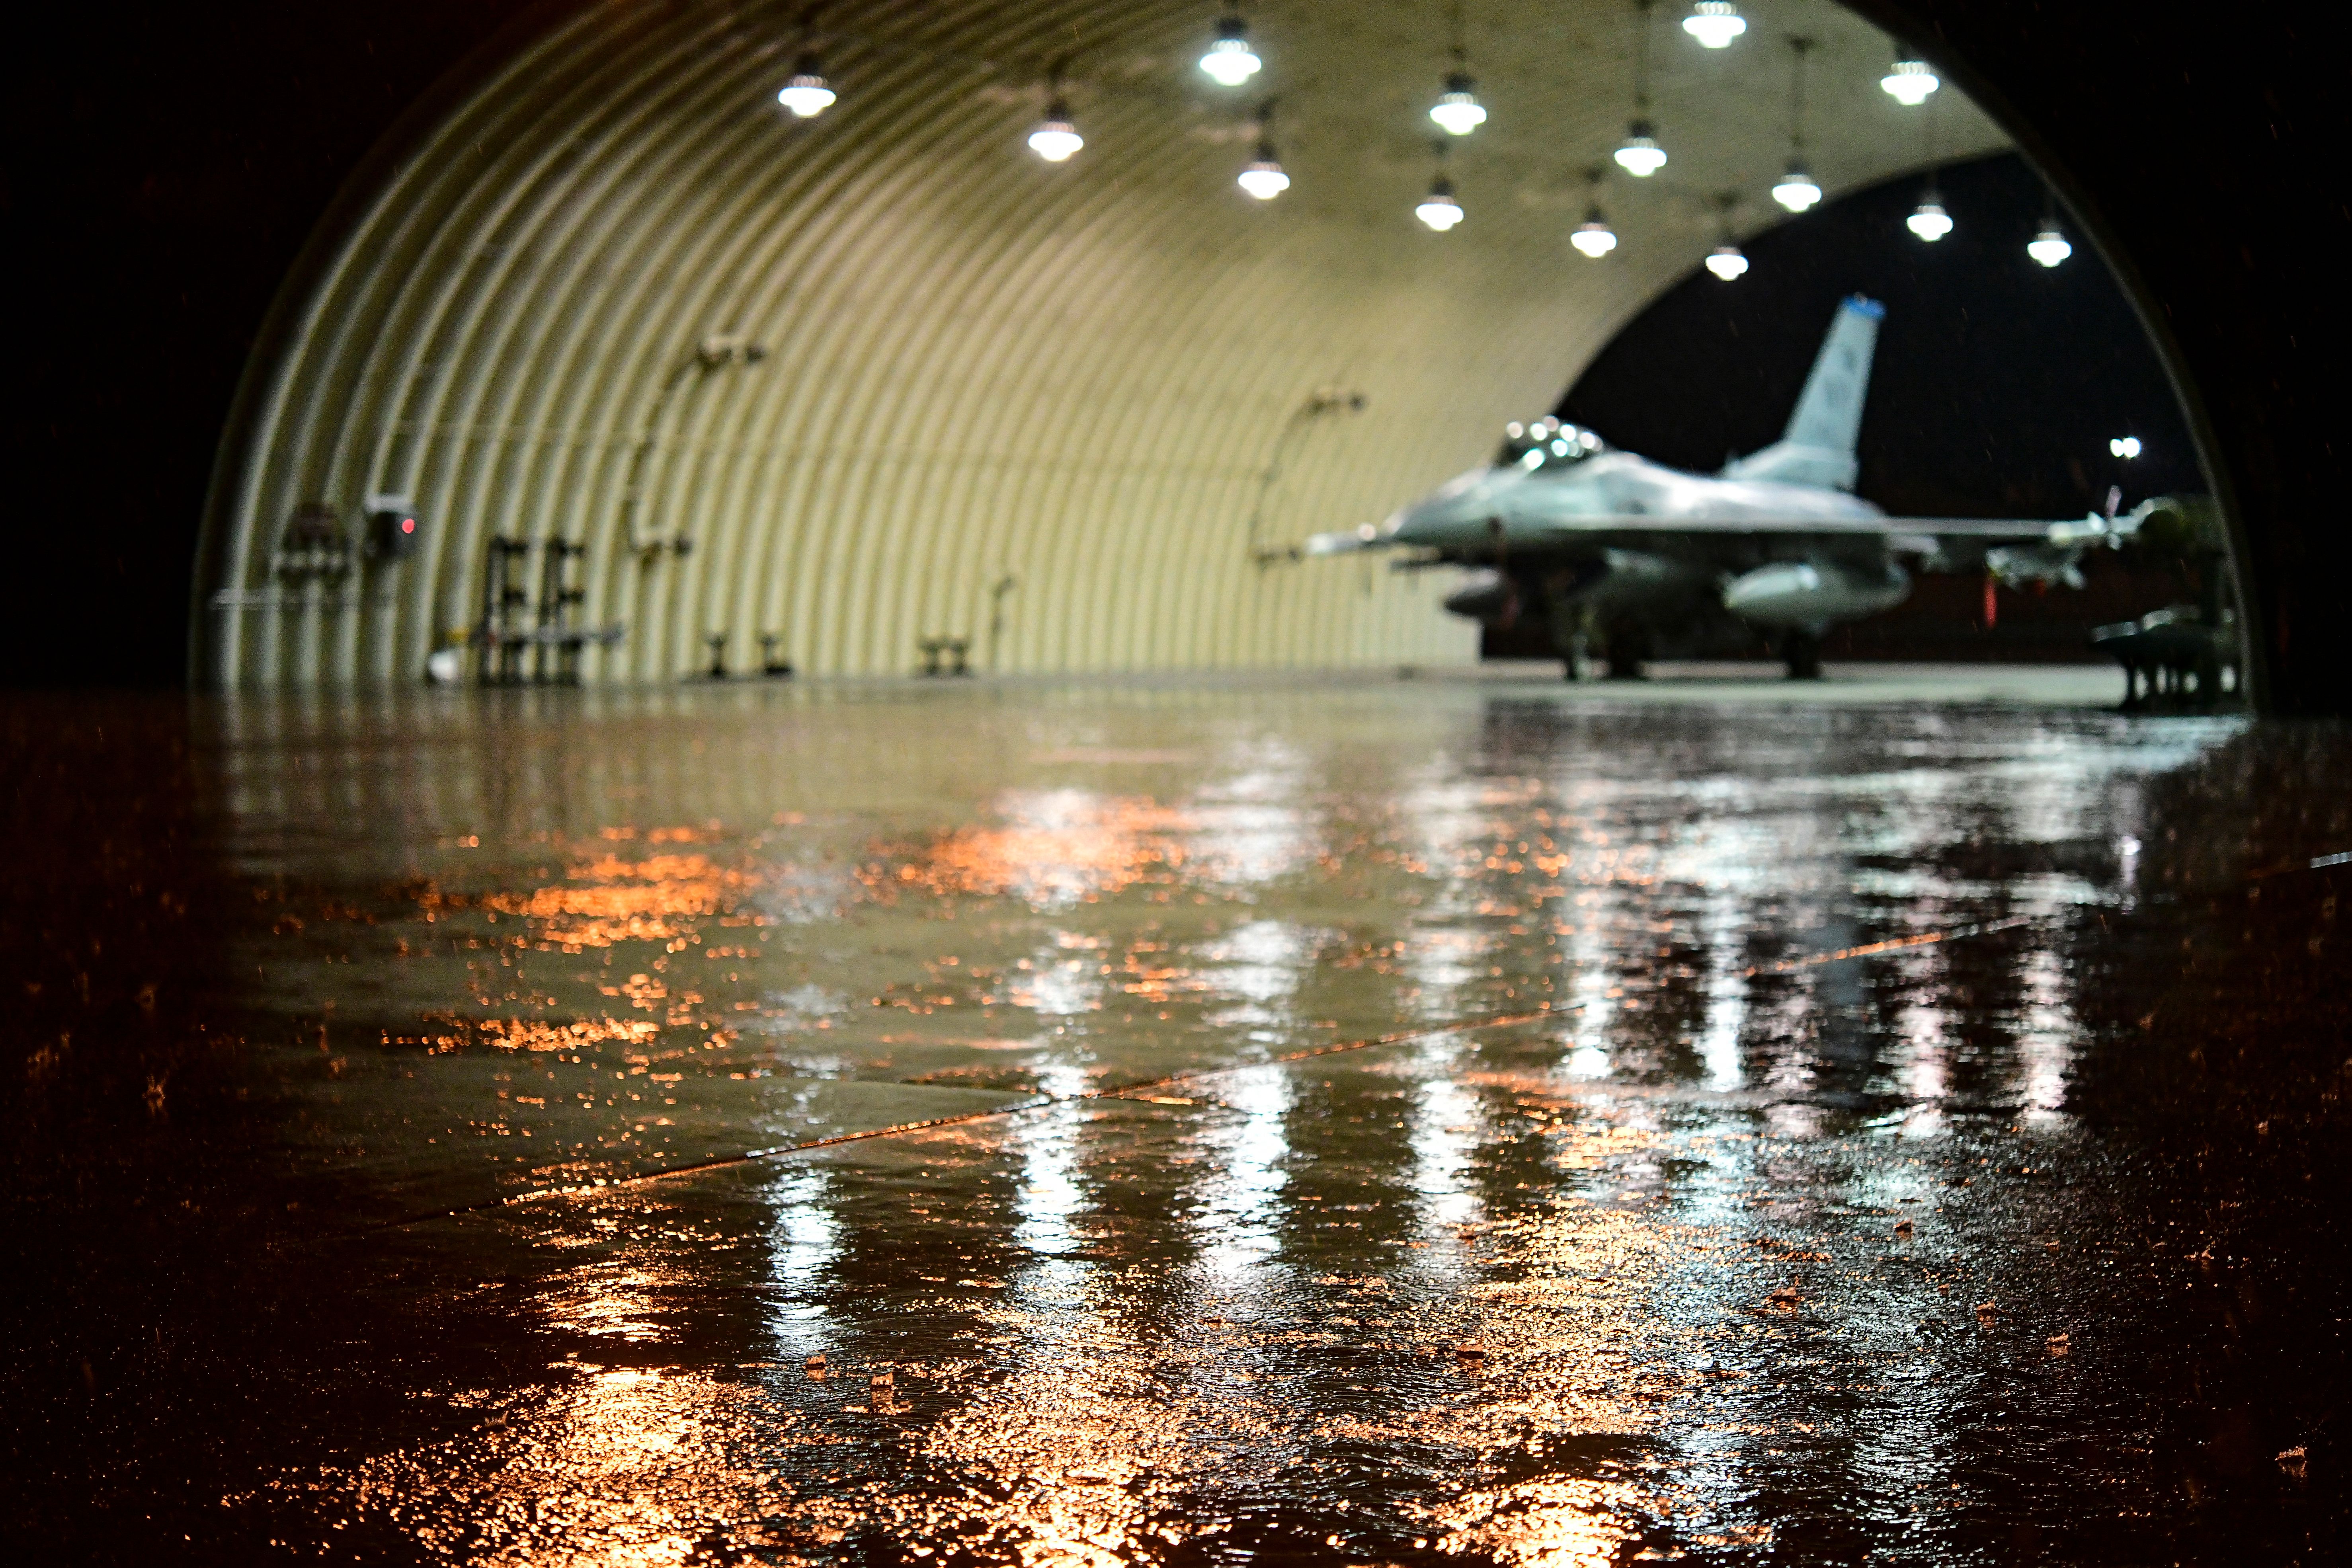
[1560,153,2206,517]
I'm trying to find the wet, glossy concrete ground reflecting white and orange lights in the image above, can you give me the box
[0,679,2352,1568]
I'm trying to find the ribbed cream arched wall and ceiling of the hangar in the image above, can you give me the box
[195,0,2004,684]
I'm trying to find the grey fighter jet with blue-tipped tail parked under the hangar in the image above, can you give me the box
[1305,294,2152,679]
